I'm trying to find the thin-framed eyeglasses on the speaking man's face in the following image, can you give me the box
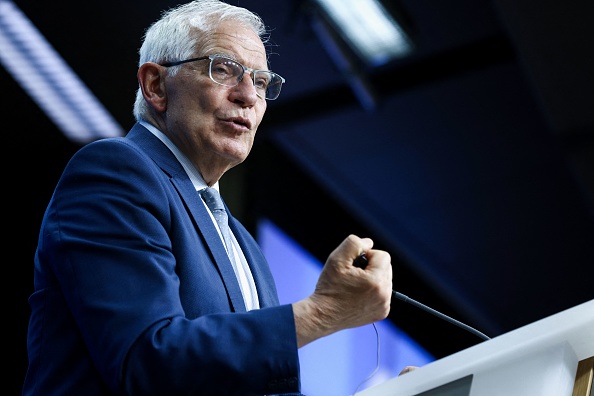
[161,55,285,100]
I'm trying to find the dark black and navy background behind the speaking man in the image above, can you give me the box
[5,0,594,394]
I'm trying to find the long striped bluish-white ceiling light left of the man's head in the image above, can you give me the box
[0,0,124,144]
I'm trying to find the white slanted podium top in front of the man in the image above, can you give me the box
[357,300,594,396]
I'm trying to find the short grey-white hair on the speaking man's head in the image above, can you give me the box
[133,0,268,121]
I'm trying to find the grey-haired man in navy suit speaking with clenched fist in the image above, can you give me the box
[23,0,392,396]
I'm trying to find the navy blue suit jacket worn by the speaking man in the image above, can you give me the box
[23,124,300,396]
